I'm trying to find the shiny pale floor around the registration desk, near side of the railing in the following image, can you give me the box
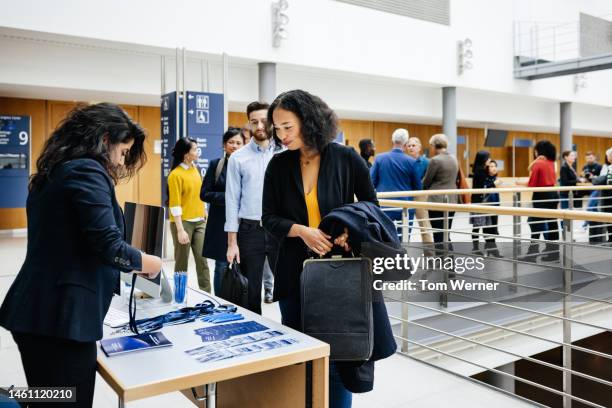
[0,228,530,408]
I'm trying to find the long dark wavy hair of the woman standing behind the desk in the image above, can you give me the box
[30,102,147,190]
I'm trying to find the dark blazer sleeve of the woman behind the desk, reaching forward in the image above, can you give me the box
[64,165,142,272]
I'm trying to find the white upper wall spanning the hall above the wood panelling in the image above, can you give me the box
[0,0,612,135]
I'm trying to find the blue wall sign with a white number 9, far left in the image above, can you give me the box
[0,115,31,208]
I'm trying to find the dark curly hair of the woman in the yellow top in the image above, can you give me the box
[268,89,338,152]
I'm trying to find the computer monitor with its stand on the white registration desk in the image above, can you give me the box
[121,202,172,299]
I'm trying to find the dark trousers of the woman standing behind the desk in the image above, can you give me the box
[12,332,97,408]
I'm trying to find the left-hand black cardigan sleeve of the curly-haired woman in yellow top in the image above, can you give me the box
[261,155,296,242]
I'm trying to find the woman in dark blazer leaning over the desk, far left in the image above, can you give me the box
[0,103,161,407]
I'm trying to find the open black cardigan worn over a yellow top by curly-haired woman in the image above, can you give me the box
[262,143,378,300]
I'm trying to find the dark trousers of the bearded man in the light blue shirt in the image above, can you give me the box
[238,220,278,314]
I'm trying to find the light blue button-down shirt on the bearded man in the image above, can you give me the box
[225,139,281,232]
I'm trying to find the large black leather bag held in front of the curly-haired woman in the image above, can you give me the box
[301,258,374,361]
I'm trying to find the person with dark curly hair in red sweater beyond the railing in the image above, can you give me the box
[525,140,559,261]
